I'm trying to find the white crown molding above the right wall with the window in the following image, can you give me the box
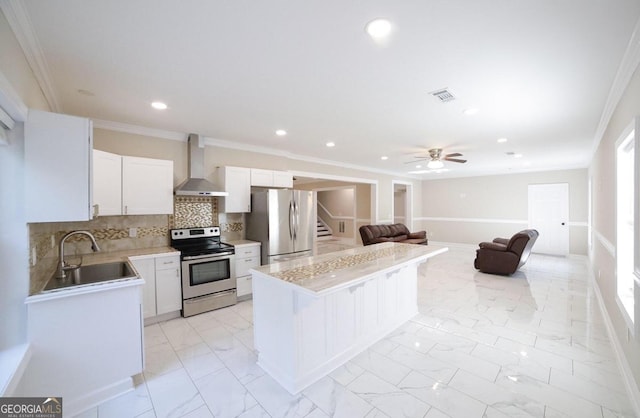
[591,14,640,158]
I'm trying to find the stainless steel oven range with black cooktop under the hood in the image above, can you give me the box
[171,226,237,317]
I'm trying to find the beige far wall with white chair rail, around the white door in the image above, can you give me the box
[416,169,588,255]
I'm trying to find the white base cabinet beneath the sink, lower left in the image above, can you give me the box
[22,279,144,417]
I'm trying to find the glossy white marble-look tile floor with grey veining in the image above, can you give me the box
[77,248,635,418]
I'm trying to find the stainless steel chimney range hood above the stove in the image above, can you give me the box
[175,134,229,196]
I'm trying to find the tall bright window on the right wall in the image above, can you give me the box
[616,124,635,330]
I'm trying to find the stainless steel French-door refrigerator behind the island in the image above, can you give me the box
[246,189,316,264]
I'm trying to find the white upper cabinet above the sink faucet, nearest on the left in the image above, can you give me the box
[24,110,93,222]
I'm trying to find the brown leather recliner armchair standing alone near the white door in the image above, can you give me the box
[473,229,538,275]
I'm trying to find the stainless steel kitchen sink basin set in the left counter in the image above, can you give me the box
[43,261,138,292]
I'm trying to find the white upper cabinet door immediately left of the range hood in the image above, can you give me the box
[122,156,173,215]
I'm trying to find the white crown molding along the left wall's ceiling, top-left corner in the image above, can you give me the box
[0,0,62,113]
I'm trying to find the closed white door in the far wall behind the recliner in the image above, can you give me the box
[529,183,569,256]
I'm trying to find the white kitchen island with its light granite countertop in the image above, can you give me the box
[251,242,448,394]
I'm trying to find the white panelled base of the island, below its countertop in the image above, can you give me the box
[253,264,418,393]
